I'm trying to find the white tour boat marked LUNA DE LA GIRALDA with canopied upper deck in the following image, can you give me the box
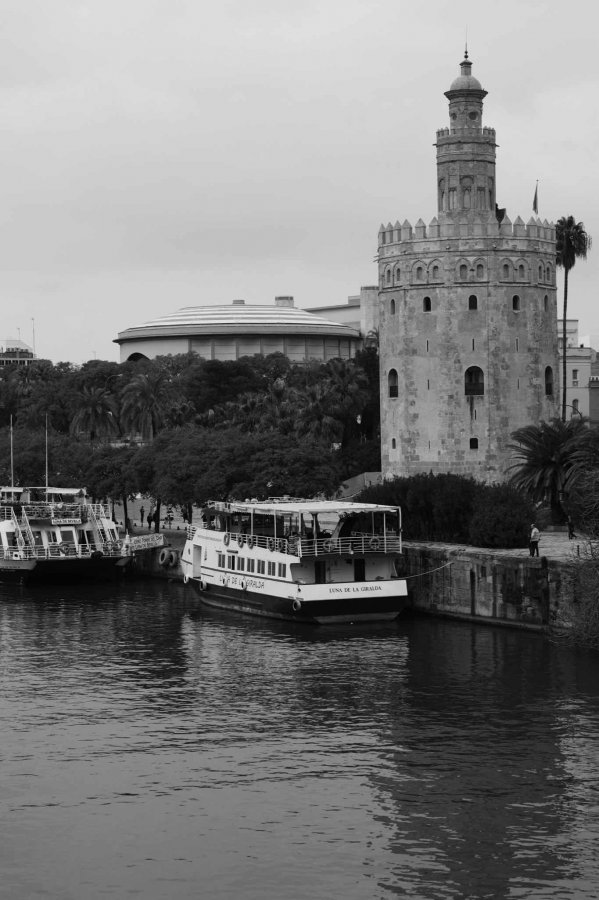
[181,498,407,624]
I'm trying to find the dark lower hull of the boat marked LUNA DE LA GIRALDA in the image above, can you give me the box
[189,578,407,625]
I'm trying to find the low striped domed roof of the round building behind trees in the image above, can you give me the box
[115,298,360,344]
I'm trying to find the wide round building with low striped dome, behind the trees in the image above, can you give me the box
[115,297,361,362]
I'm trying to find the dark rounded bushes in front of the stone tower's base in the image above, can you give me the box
[360,474,533,548]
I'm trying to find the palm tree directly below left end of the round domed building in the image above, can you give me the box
[121,370,173,441]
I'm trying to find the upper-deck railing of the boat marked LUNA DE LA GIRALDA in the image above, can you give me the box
[187,525,401,557]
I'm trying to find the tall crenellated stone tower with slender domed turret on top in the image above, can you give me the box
[378,53,559,482]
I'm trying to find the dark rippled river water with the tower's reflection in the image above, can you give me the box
[0,582,599,900]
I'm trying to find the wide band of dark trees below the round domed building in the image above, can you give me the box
[0,349,380,520]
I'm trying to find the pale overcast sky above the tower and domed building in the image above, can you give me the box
[0,0,599,364]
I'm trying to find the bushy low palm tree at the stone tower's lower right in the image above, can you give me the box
[508,417,587,522]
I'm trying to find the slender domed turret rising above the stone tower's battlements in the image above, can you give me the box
[436,51,497,221]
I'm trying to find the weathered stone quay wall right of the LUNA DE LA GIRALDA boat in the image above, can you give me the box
[398,542,580,630]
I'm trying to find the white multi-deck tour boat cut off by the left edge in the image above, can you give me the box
[0,487,131,582]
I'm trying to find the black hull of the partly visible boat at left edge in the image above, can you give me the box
[0,556,130,584]
